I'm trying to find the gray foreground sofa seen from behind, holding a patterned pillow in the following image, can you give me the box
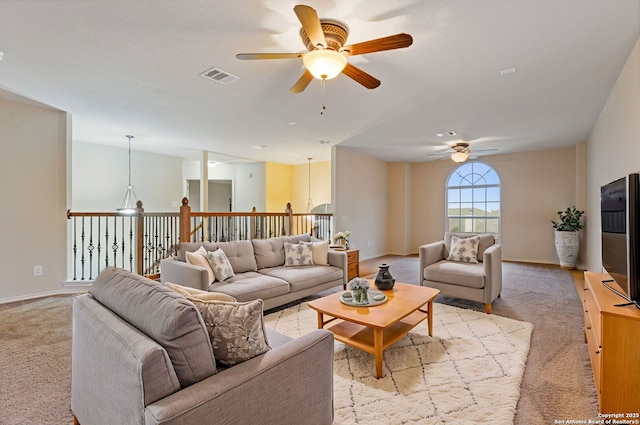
[71,268,333,425]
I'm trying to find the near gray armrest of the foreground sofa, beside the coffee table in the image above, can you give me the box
[145,329,333,425]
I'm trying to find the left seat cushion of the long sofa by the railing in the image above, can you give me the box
[209,272,290,301]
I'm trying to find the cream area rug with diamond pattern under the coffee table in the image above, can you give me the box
[265,303,533,425]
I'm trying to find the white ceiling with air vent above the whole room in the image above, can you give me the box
[0,0,640,164]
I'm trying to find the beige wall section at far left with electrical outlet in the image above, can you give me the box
[0,99,70,301]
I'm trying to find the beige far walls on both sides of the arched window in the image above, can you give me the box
[334,147,584,264]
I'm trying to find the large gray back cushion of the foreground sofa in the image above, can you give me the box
[89,267,216,387]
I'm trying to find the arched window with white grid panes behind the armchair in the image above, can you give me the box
[447,162,500,241]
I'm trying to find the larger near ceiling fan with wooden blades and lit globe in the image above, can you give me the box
[236,4,413,93]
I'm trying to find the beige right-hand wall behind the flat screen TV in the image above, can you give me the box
[586,34,640,272]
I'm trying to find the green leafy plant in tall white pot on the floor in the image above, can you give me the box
[551,206,584,270]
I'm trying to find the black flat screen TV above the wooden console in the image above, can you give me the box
[600,173,640,303]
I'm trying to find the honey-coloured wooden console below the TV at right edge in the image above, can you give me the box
[582,272,640,412]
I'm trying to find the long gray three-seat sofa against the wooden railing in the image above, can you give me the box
[160,234,348,310]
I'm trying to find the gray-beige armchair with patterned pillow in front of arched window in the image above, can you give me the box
[420,233,502,314]
